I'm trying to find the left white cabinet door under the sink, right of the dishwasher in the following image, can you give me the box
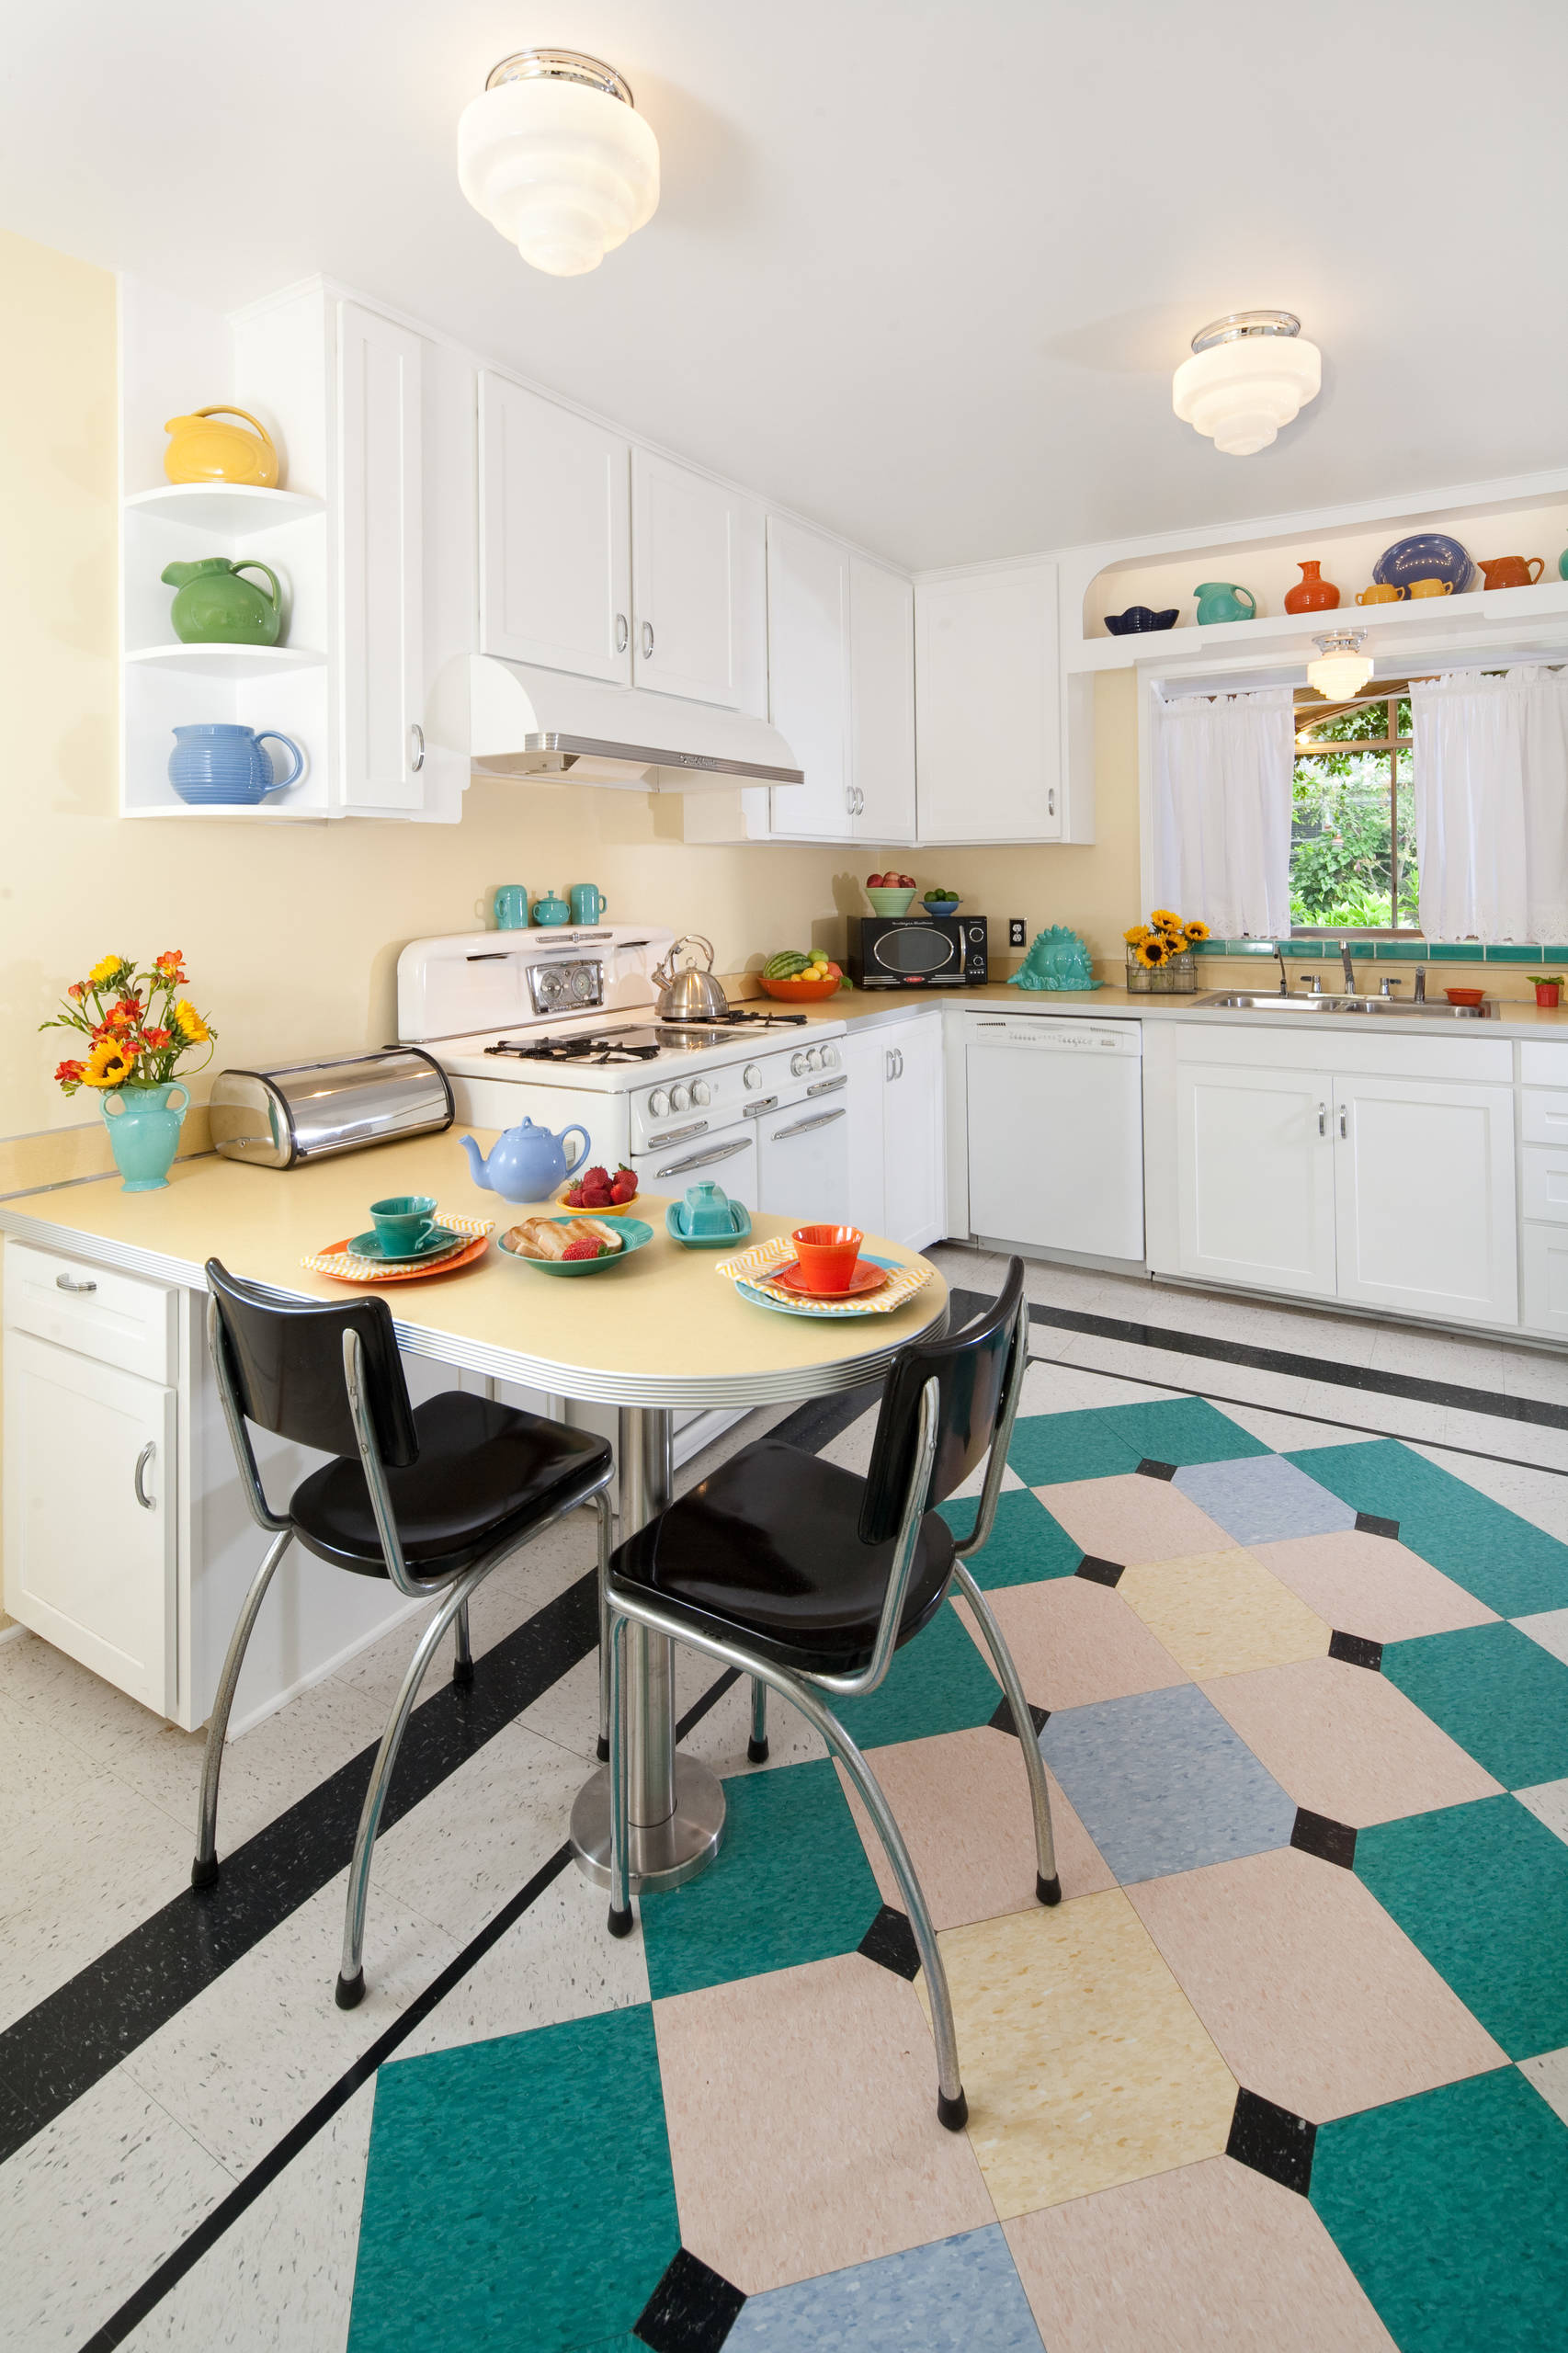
[1172,1063,1335,1294]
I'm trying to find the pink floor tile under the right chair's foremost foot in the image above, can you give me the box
[654,1953,996,2297]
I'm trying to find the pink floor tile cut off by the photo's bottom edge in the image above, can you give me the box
[1003,2158,1393,2353]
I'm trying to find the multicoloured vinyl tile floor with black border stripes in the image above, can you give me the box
[0,1247,1568,2353]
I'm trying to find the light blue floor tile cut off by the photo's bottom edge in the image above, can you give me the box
[725,2223,1040,2353]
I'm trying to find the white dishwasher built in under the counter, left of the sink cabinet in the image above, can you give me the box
[963,1012,1144,1259]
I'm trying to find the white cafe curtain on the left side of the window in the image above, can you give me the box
[1153,688,1290,938]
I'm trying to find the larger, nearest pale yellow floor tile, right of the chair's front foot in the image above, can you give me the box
[921,1887,1236,2222]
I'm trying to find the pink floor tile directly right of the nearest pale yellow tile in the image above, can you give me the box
[1128,1847,1505,2125]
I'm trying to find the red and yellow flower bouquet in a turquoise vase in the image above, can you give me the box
[40,949,214,1193]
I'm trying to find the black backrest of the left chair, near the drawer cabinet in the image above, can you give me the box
[207,1259,419,1471]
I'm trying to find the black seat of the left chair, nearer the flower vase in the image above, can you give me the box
[290,1388,609,1581]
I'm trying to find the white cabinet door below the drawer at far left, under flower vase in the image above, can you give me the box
[5,1329,176,1715]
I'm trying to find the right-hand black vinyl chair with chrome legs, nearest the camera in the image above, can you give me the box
[605,1259,1062,2131]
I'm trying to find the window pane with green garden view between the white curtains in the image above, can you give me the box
[1290,685,1420,932]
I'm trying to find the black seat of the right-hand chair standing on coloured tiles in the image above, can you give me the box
[609,1438,953,1676]
